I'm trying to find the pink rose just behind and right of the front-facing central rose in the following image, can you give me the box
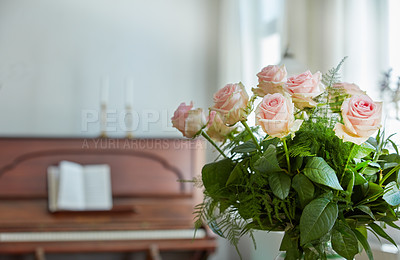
[286,70,323,109]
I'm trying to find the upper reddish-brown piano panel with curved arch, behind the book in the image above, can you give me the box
[0,138,201,198]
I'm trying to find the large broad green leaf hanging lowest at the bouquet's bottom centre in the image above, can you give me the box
[300,198,338,245]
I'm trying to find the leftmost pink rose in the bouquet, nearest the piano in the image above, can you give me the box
[171,102,207,138]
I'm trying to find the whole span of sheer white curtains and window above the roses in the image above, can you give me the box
[219,0,389,96]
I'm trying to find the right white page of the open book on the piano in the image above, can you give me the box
[83,164,112,210]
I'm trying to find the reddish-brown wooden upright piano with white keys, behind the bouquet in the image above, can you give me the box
[0,138,216,259]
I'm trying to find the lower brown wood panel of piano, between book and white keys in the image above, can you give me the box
[0,198,194,232]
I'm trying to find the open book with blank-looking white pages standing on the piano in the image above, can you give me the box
[47,161,112,212]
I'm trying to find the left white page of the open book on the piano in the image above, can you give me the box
[57,161,85,210]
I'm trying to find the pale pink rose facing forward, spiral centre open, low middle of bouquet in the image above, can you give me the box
[256,93,303,138]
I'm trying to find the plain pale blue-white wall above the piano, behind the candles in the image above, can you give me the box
[0,0,218,137]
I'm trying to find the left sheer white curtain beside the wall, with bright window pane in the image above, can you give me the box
[219,0,285,91]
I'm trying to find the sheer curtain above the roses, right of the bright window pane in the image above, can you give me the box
[286,0,388,97]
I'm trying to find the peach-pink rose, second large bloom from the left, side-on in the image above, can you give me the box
[210,83,249,125]
